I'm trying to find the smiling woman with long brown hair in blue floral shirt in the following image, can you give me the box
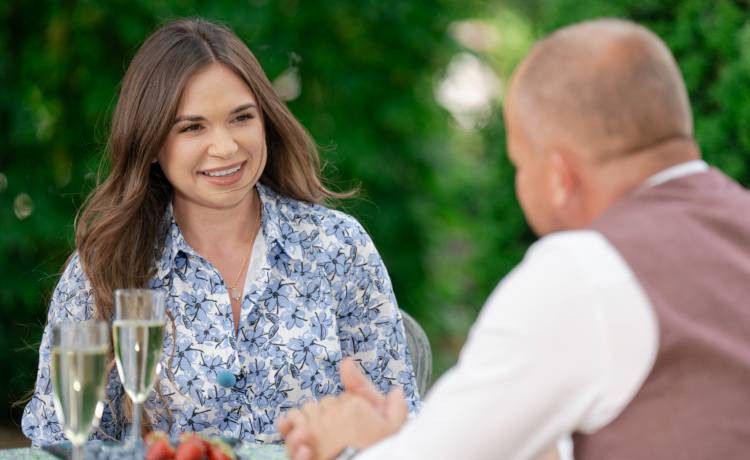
[23,19,418,445]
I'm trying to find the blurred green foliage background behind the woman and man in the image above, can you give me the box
[0,0,750,448]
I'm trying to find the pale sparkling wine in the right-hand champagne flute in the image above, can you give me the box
[112,320,164,404]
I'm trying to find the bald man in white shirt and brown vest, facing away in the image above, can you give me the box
[280,19,750,460]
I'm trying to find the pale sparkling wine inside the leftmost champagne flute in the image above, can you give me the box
[52,346,107,444]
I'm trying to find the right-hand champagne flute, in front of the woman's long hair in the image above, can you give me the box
[112,289,165,450]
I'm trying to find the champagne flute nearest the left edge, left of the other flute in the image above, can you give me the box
[51,321,109,460]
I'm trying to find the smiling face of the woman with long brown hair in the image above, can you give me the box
[158,63,267,209]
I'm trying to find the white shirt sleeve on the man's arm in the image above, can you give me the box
[357,231,658,460]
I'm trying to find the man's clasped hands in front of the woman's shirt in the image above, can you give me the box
[278,359,407,460]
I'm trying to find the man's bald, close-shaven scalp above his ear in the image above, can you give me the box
[512,19,693,163]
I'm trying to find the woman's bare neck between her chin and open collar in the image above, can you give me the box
[172,188,261,255]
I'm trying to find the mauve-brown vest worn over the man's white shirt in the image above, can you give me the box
[573,170,750,460]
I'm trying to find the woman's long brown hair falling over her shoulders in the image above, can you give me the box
[76,18,353,434]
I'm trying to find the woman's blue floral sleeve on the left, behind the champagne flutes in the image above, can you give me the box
[21,253,121,446]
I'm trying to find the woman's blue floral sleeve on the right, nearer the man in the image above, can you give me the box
[337,219,420,412]
